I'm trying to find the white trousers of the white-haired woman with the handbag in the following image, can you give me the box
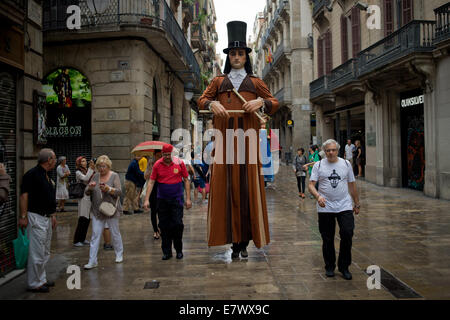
[89,215,123,264]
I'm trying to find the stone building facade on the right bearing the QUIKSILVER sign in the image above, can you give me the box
[310,0,450,199]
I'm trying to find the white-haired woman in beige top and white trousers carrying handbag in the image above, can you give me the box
[84,155,123,270]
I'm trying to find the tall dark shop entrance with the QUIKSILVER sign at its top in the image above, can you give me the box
[400,90,425,191]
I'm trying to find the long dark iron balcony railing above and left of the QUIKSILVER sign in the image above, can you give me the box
[358,20,435,76]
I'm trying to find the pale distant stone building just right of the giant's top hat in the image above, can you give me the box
[253,0,313,161]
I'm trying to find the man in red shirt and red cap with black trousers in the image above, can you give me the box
[144,144,192,260]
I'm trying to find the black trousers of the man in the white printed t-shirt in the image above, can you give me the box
[319,210,355,270]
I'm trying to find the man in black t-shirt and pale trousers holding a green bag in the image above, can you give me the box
[19,149,56,292]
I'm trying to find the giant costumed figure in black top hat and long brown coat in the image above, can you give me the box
[198,21,278,258]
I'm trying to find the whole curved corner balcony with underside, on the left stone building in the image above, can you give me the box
[43,0,200,88]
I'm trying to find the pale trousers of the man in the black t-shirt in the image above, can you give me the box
[27,212,52,289]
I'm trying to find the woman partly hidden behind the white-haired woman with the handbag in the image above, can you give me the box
[73,156,95,247]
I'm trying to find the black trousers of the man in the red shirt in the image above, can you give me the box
[158,198,184,254]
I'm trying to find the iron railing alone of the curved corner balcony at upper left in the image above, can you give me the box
[43,0,200,90]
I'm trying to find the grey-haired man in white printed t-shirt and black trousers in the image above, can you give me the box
[308,139,360,280]
